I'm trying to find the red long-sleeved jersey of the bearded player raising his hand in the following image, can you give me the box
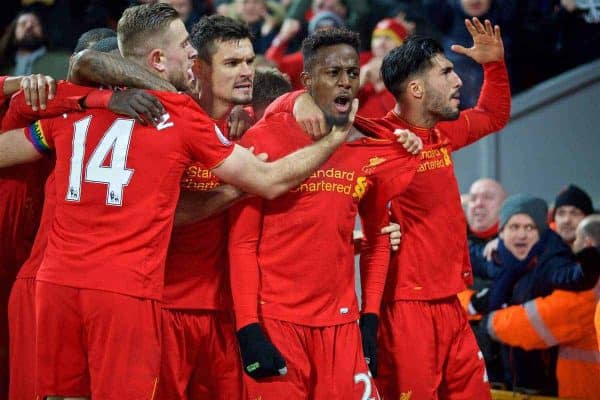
[355,62,510,302]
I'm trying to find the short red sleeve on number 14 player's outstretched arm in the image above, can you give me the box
[181,97,235,169]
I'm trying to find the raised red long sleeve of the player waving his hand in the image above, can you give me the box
[437,61,511,151]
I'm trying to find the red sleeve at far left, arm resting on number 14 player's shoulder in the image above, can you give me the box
[2,81,94,130]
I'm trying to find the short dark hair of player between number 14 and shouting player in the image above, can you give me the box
[190,14,253,63]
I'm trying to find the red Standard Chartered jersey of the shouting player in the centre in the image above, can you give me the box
[229,113,417,328]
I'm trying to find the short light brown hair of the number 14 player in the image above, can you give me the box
[117,3,179,57]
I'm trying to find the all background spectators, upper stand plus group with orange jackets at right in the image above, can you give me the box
[0,0,600,398]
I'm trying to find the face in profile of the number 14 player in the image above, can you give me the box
[163,18,198,91]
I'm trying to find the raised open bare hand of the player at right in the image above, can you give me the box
[450,18,504,64]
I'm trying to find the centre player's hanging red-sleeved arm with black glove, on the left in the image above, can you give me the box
[228,197,287,379]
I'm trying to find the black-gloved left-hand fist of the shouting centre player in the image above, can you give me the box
[237,323,287,379]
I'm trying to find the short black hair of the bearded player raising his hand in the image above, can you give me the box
[381,36,444,99]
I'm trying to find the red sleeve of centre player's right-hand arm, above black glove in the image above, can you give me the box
[359,187,390,315]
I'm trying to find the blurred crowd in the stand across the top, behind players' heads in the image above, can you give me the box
[0,0,600,108]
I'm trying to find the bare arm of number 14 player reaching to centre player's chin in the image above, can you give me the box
[213,100,358,199]
